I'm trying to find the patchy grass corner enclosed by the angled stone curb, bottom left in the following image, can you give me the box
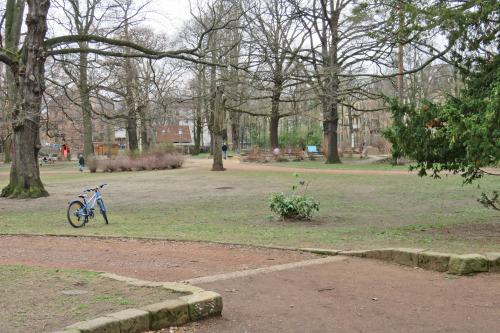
[0,265,180,333]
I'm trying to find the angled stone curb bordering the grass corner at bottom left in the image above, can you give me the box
[54,273,223,333]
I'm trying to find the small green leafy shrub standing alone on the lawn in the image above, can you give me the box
[268,173,319,219]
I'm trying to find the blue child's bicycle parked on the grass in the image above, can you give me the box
[68,184,108,228]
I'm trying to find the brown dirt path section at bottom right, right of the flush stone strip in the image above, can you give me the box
[187,258,500,333]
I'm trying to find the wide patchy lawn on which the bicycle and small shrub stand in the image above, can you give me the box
[0,168,500,253]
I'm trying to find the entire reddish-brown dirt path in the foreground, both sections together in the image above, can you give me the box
[0,236,500,333]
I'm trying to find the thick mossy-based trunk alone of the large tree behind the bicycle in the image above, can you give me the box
[2,0,50,198]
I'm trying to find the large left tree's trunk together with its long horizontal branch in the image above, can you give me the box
[0,0,244,198]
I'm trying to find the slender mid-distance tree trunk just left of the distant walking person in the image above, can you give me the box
[212,86,226,171]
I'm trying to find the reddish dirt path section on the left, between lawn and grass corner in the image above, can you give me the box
[0,236,321,282]
